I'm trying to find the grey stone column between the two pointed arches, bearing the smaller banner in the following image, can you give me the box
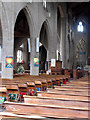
[30,37,39,75]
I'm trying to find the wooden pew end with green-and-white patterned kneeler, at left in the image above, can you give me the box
[6,85,20,102]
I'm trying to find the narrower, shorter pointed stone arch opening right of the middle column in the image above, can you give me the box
[39,20,50,70]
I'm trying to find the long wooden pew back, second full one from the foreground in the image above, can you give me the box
[24,95,88,110]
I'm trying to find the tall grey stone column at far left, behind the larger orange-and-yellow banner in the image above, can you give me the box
[1,2,14,79]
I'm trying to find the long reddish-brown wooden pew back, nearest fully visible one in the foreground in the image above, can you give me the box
[5,102,88,118]
